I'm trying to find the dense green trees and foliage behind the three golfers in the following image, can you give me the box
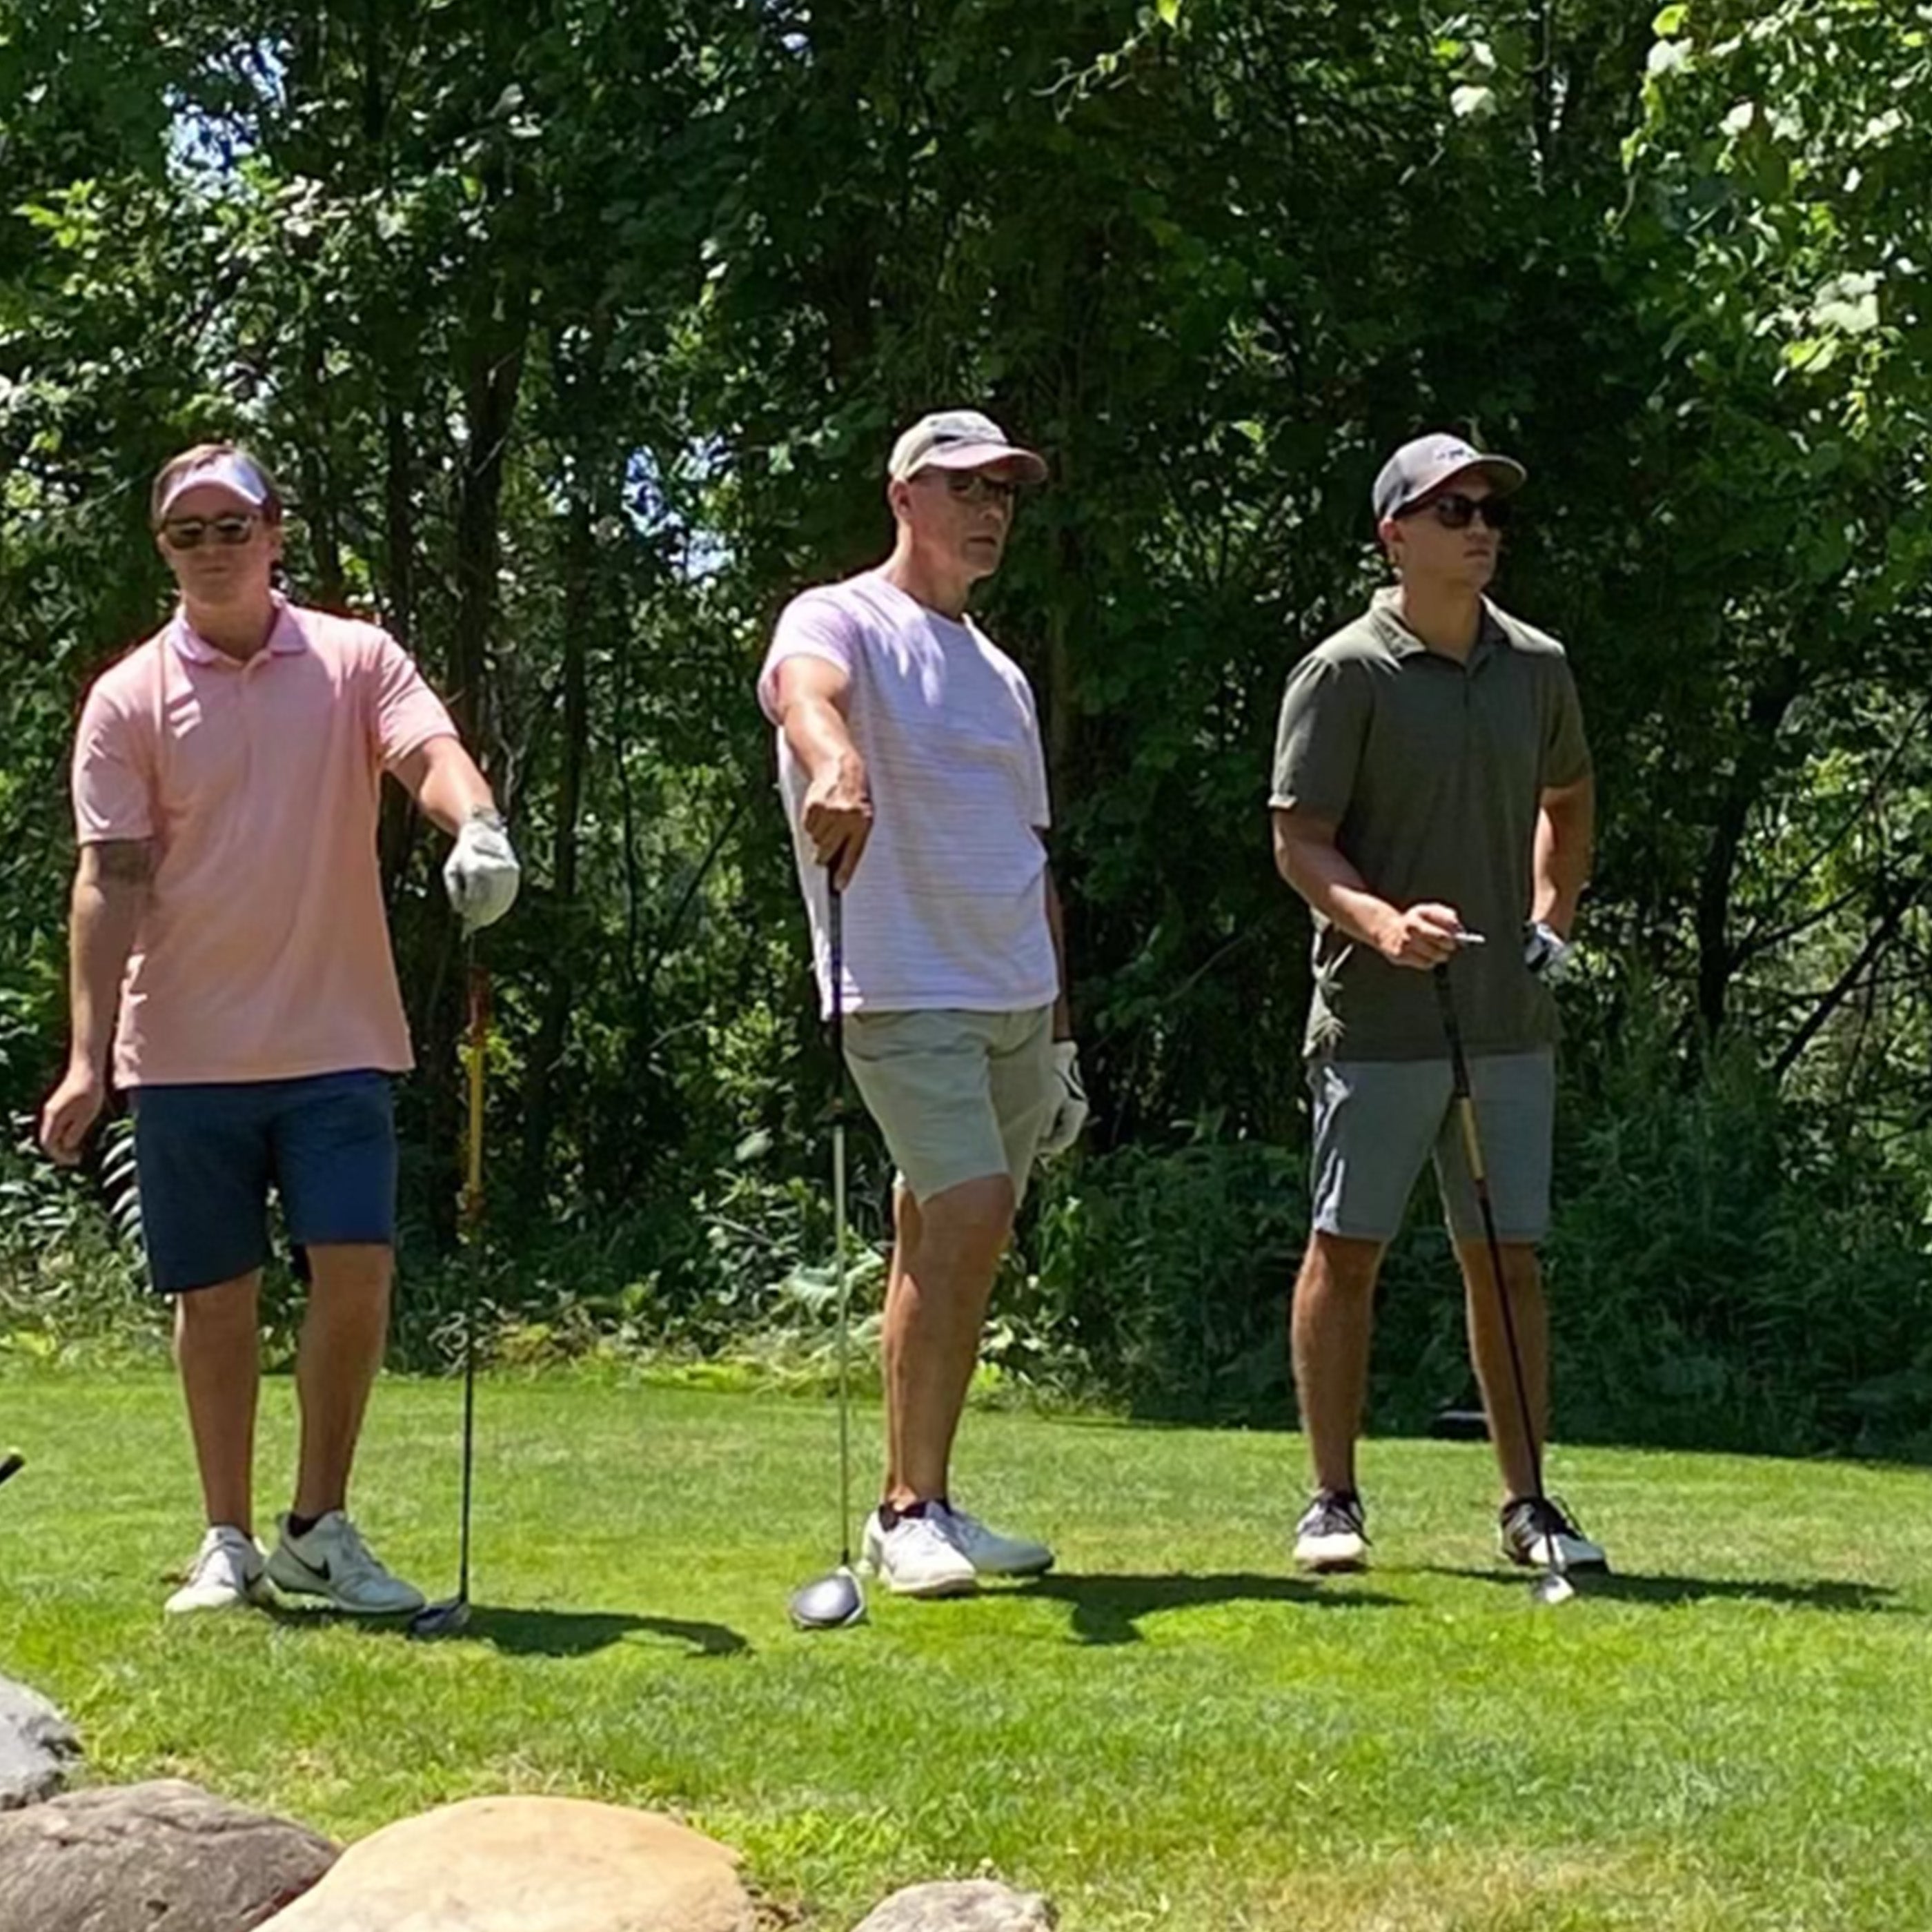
[0,0,1932,1449]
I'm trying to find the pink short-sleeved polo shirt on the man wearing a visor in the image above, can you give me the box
[73,603,456,1087]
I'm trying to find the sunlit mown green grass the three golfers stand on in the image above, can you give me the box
[0,1372,1932,1932]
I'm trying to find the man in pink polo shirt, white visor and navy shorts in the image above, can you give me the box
[41,444,518,1615]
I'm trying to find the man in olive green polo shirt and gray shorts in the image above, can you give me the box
[1270,435,1606,1570]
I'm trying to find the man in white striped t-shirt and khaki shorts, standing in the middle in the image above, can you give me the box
[758,410,1086,1596]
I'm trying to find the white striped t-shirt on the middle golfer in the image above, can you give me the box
[758,570,1058,1012]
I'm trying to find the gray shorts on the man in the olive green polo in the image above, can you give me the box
[1308,1047,1557,1242]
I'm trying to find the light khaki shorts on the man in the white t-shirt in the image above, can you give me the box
[845,1007,1058,1202]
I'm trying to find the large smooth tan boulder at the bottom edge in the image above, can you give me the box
[261,1799,758,1932]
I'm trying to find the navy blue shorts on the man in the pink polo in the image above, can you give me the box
[131,1070,396,1294]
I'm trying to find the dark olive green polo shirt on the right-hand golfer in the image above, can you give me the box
[1270,591,1590,1061]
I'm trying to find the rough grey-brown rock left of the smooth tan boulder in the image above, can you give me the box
[0,1780,336,1932]
